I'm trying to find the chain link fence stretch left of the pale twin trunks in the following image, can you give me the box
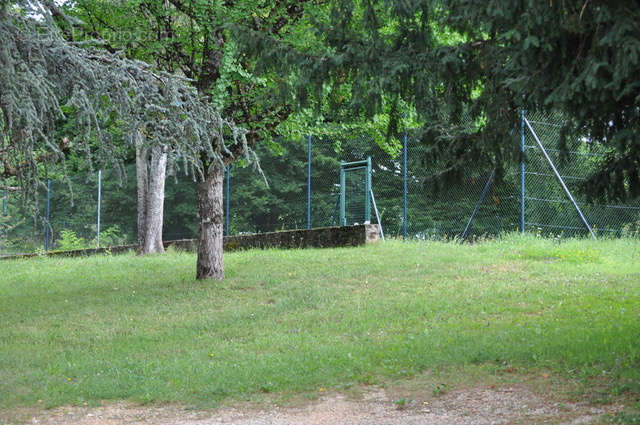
[0,172,136,254]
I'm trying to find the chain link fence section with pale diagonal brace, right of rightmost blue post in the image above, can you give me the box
[524,113,640,236]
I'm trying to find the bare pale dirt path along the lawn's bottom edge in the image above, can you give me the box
[3,385,618,425]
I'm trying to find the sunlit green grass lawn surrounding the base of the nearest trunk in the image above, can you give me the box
[0,235,640,408]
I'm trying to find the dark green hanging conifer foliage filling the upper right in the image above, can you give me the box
[282,0,640,200]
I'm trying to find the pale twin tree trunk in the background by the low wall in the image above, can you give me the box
[136,135,168,254]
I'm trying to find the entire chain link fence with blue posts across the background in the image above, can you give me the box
[0,110,640,255]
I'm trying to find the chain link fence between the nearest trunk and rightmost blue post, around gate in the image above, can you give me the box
[228,135,519,239]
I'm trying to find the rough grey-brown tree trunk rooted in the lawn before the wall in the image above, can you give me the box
[196,161,224,280]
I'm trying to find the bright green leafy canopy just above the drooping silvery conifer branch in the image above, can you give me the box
[66,0,312,151]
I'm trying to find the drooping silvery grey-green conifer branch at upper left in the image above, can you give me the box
[0,0,249,202]
